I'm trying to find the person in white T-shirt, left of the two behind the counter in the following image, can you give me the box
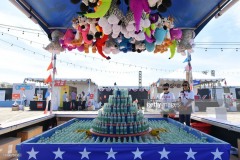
[159,83,175,118]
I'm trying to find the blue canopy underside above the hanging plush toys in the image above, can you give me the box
[15,0,230,35]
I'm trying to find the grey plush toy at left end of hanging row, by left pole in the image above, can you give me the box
[44,30,64,54]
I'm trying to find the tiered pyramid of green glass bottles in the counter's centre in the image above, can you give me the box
[92,89,149,136]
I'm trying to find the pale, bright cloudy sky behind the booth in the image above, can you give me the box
[0,0,240,86]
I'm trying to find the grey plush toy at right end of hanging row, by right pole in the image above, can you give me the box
[177,29,195,55]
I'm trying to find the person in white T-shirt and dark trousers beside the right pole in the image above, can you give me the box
[179,81,194,126]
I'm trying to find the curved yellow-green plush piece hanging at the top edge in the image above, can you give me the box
[85,0,111,18]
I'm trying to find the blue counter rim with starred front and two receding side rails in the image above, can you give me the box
[17,118,231,160]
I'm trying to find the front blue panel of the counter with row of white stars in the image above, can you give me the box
[19,144,229,160]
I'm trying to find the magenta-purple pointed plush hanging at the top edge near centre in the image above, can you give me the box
[130,0,151,33]
